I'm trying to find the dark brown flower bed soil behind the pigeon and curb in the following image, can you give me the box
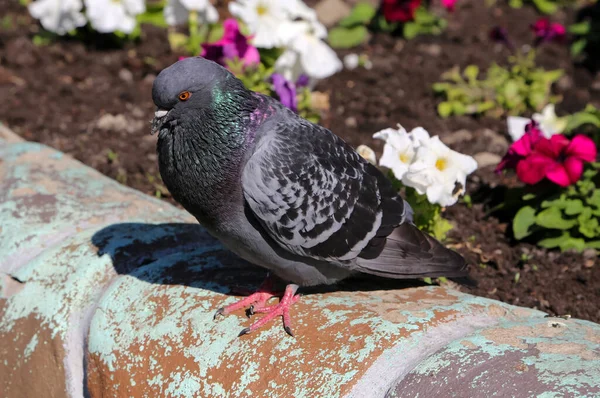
[0,0,600,322]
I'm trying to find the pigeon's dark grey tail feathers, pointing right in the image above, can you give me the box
[356,223,467,279]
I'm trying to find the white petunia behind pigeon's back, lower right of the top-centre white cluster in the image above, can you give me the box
[275,21,343,79]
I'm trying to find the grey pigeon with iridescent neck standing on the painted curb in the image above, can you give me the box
[152,57,466,335]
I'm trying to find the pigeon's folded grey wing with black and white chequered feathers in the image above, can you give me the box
[242,118,464,278]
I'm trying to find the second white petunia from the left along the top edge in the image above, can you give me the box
[85,0,146,33]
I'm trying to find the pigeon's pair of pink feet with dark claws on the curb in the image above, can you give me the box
[215,279,300,336]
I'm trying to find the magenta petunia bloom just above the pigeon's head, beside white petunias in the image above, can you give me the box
[201,18,260,66]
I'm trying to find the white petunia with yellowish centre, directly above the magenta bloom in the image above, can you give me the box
[229,0,289,48]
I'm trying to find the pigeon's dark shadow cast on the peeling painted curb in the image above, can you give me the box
[92,223,436,295]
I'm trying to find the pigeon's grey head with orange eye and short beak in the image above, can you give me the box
[152,57,237,134]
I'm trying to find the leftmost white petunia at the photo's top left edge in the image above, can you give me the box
[28,0,86,35]
